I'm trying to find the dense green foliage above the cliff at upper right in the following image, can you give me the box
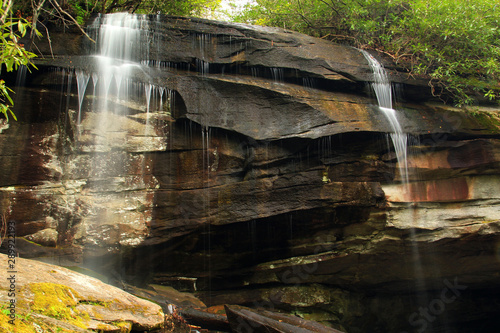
[234,0,500,105]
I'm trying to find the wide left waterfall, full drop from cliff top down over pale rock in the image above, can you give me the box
[67,13,173,260]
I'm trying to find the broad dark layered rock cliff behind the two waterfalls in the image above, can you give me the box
[0,16,500,332]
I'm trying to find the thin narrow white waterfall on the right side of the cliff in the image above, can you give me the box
[361,50,409,184]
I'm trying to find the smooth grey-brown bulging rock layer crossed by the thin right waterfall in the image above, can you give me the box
[166,75,500,140]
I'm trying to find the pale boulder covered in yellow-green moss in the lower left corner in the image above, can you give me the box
[0,254,164,332]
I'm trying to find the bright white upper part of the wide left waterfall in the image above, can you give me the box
[76,13,177,144]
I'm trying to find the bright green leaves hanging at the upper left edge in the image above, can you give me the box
[0,0,39,120]
